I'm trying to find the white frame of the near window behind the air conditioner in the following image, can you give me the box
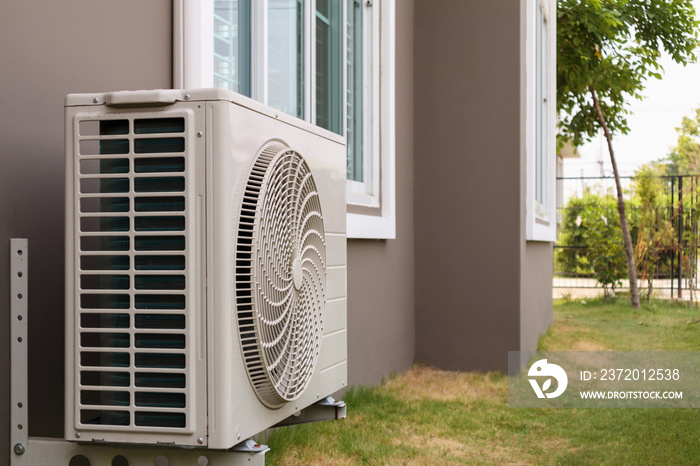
[173,0,396,239]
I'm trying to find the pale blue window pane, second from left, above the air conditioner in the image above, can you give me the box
[267,0,304,118]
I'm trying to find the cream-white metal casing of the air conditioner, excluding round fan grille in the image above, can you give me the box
[65,89,347,449]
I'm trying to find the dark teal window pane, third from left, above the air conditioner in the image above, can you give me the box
[316,0,344,134]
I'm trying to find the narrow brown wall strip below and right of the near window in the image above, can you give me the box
[348,0,415,385]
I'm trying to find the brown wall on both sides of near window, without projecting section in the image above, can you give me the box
[0,0,415,448]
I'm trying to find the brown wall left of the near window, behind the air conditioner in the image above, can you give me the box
[0,0,172,444]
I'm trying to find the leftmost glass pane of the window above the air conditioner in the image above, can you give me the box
[214,0,251,97]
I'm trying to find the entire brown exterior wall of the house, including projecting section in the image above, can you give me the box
[0,0,552,452]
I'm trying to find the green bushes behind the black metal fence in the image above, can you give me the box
[554,169,700,303]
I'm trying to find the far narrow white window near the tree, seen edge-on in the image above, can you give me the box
[525,0,556,241]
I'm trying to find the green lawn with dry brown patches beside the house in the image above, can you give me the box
[266,300,700,465]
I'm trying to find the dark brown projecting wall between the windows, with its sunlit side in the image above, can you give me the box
[414,0,551,370]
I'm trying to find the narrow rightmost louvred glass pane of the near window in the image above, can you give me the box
[346,0,364,182]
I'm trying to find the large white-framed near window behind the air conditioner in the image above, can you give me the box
[174,0,395,238]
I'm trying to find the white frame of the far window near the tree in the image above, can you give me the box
[525,0,556,242]
